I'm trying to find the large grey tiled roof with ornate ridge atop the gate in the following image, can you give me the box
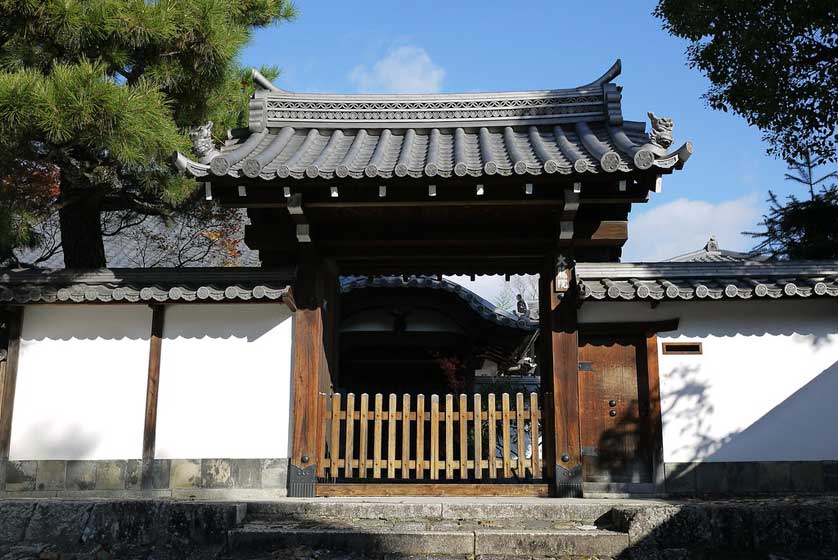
[175,61,692,180]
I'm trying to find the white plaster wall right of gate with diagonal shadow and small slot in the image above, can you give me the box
[580,299,838,462]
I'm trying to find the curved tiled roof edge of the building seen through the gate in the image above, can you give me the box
[340,276,538,331]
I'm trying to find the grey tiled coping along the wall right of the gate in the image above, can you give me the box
[576,261,838,301]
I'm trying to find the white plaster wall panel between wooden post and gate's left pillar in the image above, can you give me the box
[156,304,293,459]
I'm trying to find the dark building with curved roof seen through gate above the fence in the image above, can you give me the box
[335,276,539,395]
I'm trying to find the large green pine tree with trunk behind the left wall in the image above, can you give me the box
[0,0,294,268]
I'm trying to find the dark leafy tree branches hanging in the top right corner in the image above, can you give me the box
[654,0,838,161]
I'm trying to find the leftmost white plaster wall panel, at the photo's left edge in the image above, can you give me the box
[10,305,151,460]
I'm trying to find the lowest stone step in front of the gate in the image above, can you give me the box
[228,523,629,558]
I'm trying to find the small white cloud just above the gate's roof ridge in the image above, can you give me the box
[349,45,445,93]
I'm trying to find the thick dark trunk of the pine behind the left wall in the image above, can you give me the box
[58,193,107,268]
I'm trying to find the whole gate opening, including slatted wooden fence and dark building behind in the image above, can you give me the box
[317,276,547,495]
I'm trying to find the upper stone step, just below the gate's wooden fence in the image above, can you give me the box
[247,500,614,524]
